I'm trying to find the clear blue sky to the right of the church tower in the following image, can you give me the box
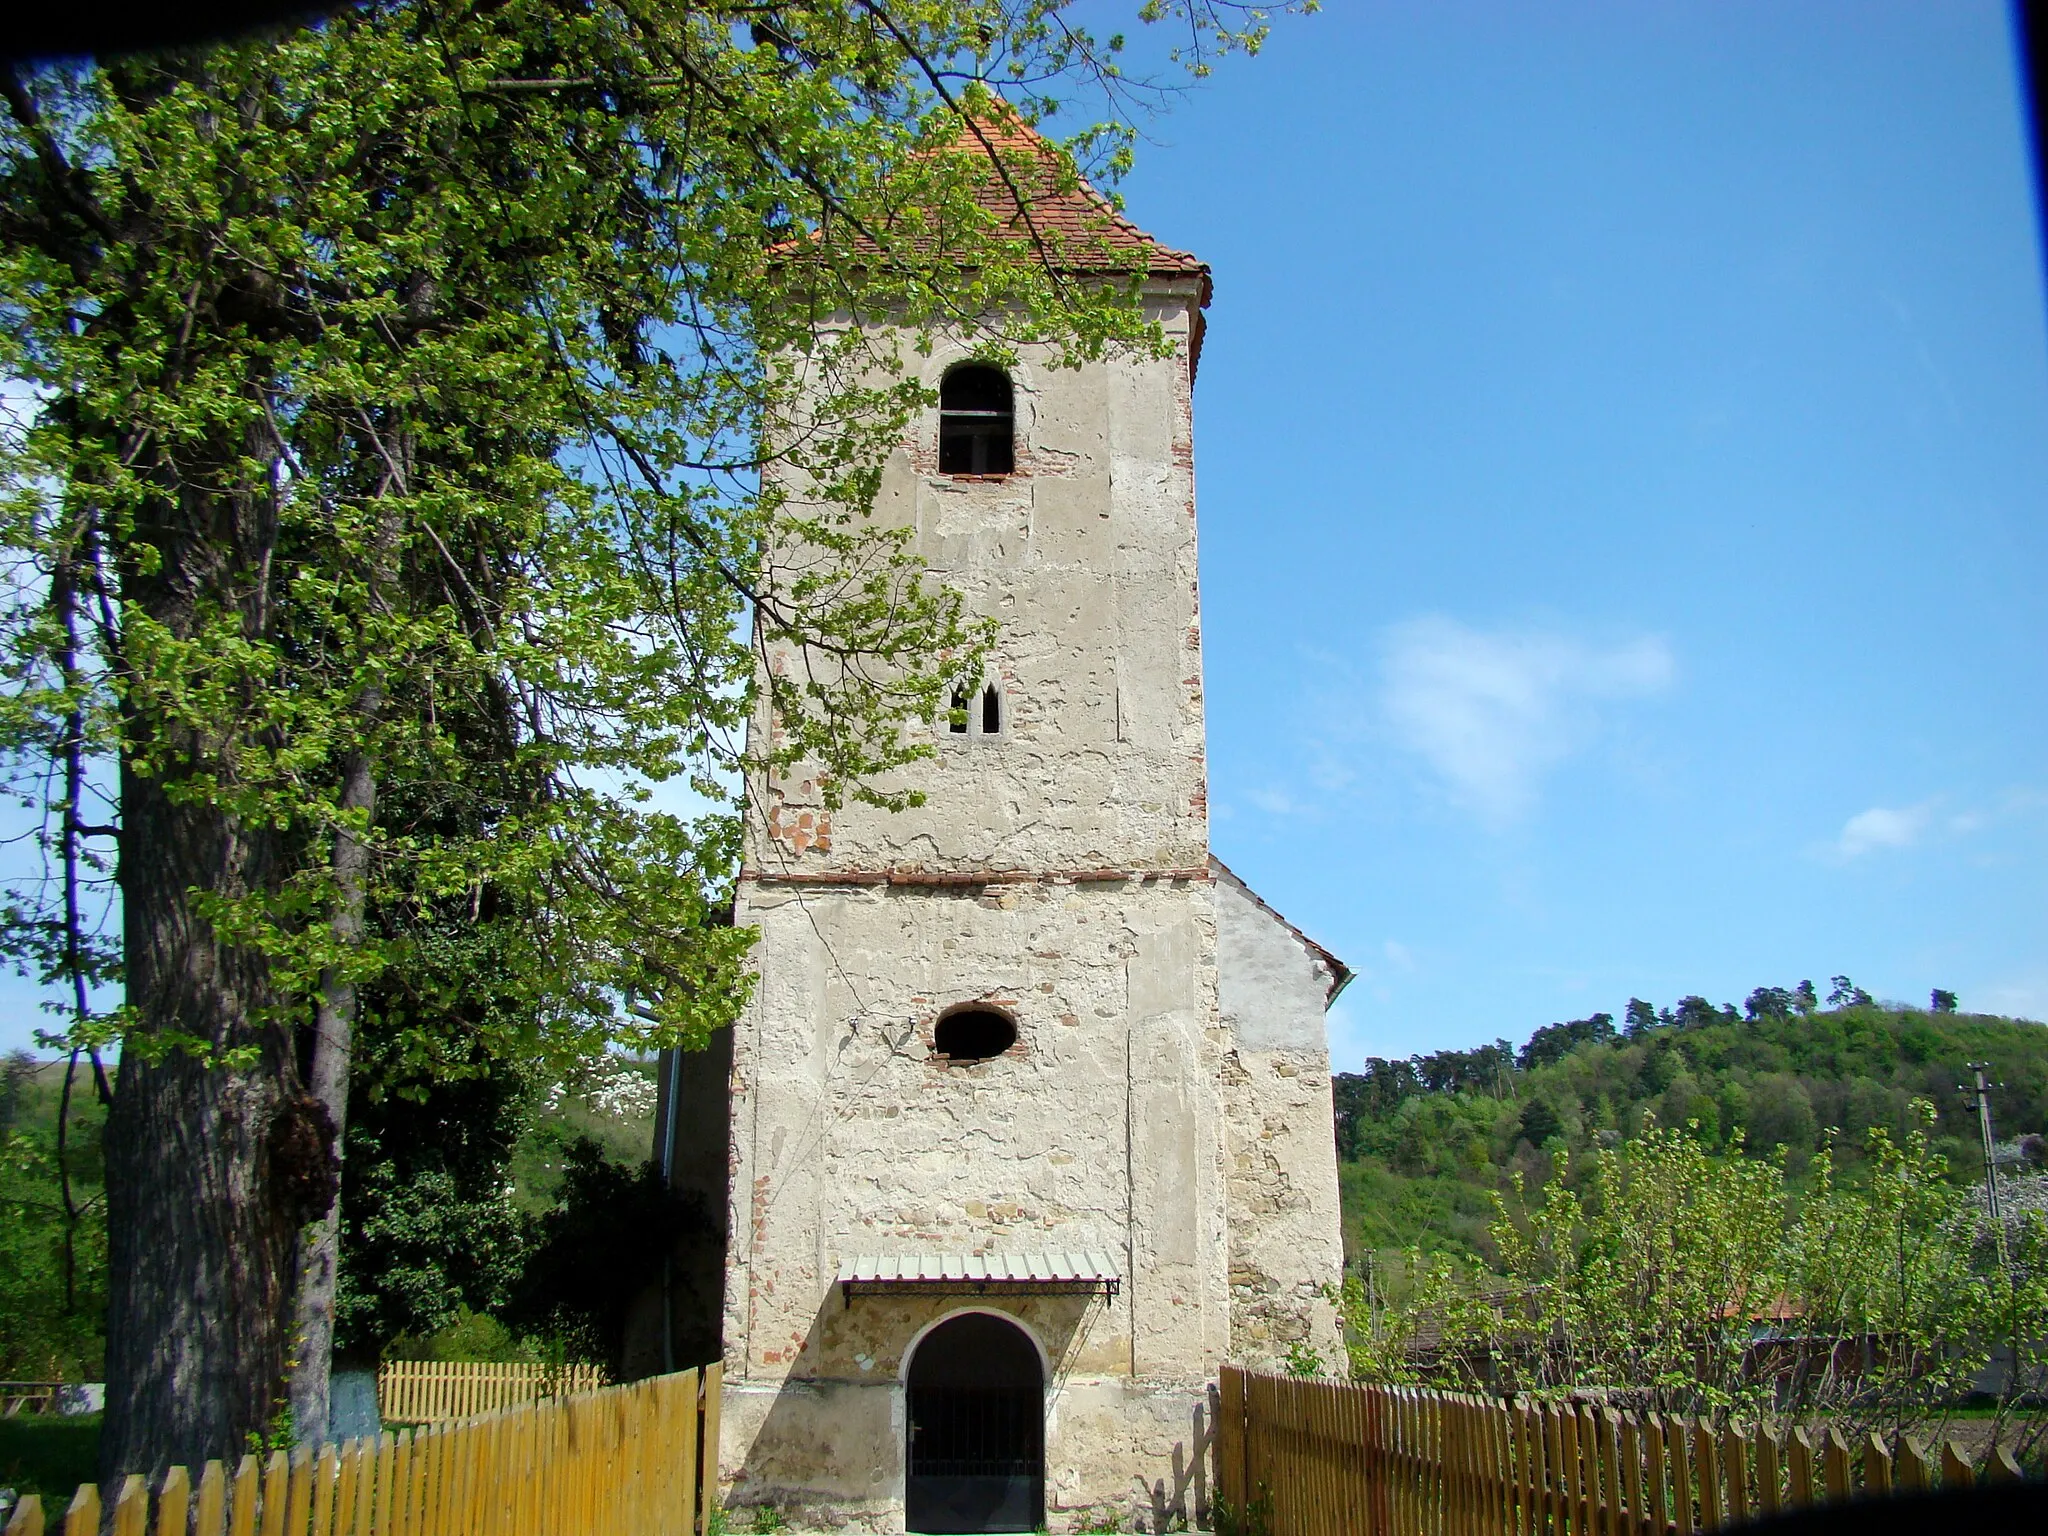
[1124,0,2048,1069]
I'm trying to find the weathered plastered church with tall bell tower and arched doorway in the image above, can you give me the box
[657,126,1348,1530]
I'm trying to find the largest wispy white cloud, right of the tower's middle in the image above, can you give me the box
[1380,616,1675,823]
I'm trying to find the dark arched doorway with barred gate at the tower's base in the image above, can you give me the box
[903,1313,1044,1532]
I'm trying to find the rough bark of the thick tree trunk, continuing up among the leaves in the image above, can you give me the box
[100,454,334,1485]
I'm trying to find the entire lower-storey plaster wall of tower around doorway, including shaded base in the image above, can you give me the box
[723,879,1231,1528]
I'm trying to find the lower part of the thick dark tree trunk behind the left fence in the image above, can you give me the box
[100,764,303,1487]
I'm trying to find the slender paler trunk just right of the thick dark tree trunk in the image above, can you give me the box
[291,741,383,1440]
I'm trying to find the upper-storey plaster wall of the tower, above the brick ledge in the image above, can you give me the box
[748,289,1208,872]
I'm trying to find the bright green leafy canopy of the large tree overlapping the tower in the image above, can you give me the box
[0,0,1262,1059]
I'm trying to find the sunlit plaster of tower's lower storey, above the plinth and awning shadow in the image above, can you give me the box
[725,881,1229,1380]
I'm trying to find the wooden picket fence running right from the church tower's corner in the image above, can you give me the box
[1217,1366,2019,1536]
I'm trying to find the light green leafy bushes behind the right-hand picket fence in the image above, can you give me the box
[1343,1102,2048,1442]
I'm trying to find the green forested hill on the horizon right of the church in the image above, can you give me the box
[1335,977,2048,1266]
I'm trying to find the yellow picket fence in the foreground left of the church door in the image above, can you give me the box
[6,1364,719,1536]
